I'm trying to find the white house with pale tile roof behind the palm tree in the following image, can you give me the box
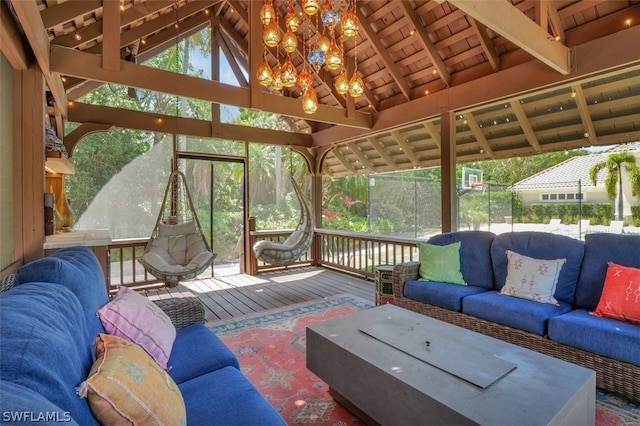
[512,142,640,216]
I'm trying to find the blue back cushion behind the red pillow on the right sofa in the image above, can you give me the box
[575,234,640,311]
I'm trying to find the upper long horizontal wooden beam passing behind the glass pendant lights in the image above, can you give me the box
[51,46,373,129]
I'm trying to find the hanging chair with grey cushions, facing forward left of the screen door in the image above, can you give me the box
[139,171,216,284]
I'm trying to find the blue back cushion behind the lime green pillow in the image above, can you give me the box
[428,231,495,289]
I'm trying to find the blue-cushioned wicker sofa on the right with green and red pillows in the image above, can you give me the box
[393,231,640,400]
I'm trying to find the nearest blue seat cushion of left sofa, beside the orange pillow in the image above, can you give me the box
[178,366,286,426]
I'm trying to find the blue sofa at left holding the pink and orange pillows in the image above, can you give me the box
[0,247,285,426]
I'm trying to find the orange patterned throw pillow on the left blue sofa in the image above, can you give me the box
[78,334,187,425]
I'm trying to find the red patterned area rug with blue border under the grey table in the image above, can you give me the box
[207,294,640,426]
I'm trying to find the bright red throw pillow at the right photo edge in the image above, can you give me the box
[593,262,640,324]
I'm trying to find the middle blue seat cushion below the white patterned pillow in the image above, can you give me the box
[462,290,571,336]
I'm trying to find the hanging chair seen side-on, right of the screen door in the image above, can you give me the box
[253,179,313,266]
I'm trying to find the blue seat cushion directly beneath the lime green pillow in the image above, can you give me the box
[404,280,489,312]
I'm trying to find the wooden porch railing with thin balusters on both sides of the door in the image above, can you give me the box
[109,229,418,292]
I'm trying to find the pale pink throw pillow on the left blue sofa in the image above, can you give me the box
[97,286,176,370]
